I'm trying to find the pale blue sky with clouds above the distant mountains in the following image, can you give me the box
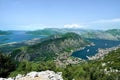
[0,0,120,30]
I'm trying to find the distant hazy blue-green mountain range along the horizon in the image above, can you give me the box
[27,28,120,40]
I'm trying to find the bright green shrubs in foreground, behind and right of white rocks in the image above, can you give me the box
[10,48,120,80]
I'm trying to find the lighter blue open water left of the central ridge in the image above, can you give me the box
[0,31,45,44]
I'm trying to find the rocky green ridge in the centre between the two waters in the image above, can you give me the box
[11,33,90,61]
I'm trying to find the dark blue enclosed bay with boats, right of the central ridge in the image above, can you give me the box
[72,39,120,60]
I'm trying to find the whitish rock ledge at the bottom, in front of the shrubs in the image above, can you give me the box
[0,70,63,80]
